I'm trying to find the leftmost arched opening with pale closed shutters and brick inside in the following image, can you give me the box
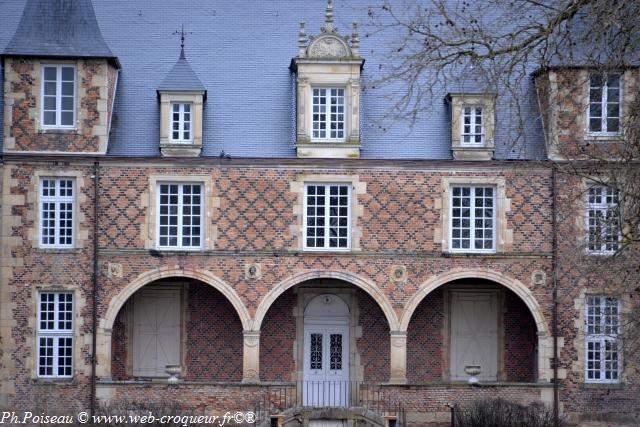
[111,277,243,381]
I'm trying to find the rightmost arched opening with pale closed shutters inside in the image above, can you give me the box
[407,278,538,383]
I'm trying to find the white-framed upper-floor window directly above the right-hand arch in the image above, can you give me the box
[449,185,496,252]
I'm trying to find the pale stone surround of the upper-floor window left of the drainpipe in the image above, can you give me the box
[27,169,89,252]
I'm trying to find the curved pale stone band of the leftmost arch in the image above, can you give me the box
[100,267,251,331]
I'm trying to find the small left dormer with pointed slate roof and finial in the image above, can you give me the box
[158,29,207,157]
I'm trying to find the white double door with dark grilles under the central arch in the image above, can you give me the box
[302,323,350,406]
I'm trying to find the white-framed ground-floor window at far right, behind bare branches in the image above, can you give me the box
[585,296,621,383]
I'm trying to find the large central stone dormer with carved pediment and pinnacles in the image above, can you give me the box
[291,0,364,158]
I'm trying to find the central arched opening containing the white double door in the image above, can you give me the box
[256,278,390,383]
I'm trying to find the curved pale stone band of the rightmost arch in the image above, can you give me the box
[399,269,549,336]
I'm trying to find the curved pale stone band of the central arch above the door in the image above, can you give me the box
[253,270,399,331]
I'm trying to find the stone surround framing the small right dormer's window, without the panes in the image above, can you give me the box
[449,93,496,160]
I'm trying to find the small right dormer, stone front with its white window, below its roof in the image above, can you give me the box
[447,93,496,160]
